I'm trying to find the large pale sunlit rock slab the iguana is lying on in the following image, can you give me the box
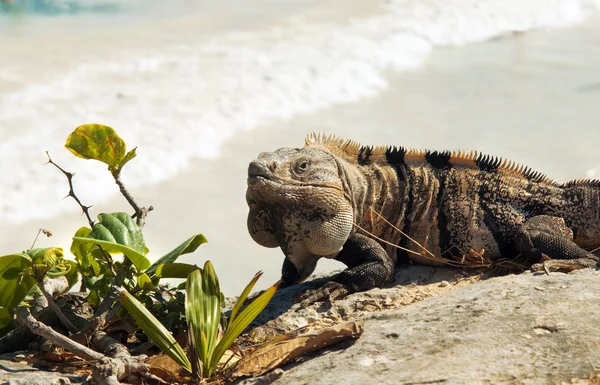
[250,266,600,385]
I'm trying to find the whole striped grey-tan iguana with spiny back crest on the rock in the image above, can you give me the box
[246,133,600,303]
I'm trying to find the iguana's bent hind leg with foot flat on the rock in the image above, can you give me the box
[515,215,598,272]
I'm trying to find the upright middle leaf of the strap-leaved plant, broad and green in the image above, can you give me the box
[185,261,221,377]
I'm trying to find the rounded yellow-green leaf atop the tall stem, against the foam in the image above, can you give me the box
[65,124,125,169]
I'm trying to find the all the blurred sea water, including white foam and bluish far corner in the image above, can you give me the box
[0,0,600,225]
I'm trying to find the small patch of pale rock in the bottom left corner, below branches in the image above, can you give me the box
[0,353,86,385]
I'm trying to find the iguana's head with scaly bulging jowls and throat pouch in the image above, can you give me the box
[246,146,354,280]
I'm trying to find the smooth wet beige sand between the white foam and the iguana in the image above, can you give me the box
[0,2,600,295]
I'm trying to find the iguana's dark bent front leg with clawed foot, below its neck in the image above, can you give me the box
[298,234,394,306]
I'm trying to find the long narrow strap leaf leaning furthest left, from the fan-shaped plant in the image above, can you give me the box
[121,289,192,373]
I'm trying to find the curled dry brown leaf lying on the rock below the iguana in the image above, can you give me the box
[232,321,363,377]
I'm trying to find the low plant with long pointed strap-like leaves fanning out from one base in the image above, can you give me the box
[121,261,279,379]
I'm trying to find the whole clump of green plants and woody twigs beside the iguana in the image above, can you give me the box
[0,124,278,384]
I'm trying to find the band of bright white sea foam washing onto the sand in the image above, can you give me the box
[0,0,600,225]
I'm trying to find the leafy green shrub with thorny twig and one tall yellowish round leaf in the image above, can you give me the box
[0,124,207,337]
